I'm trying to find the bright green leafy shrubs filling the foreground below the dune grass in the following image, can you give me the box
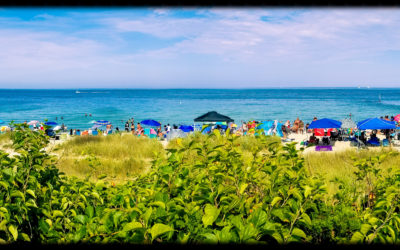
[0,125,400,243]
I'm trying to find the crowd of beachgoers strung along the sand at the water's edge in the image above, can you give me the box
[4,114,400,148]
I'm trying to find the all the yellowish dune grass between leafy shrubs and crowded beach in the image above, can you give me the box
[51,133,400,200]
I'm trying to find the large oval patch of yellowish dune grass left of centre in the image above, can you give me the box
[55,134,165,183]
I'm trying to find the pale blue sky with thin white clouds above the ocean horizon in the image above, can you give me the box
[0,7,400,89]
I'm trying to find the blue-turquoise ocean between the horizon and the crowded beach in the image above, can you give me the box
[0,88,400,129]
